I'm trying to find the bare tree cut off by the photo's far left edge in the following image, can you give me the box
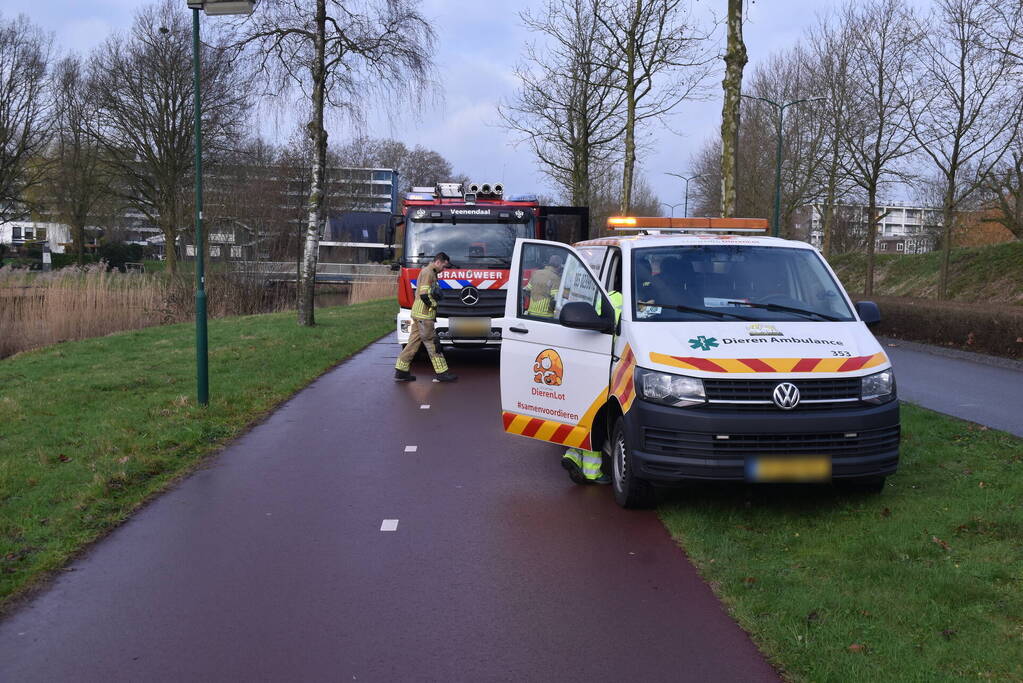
[0,15,51,224]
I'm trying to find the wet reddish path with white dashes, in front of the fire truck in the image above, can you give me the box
[0,342,776,682]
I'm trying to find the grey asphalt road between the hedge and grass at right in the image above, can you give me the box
[884,339,1023,437]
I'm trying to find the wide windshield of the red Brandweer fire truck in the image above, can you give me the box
[405,219,533,268]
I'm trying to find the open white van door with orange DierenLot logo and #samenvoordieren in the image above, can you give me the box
[501,239,615,449]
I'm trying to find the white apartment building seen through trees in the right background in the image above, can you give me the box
[795,202,942,254]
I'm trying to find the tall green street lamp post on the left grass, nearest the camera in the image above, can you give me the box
[187,0,256,406]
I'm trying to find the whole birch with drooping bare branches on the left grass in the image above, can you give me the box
[238,0,435,325]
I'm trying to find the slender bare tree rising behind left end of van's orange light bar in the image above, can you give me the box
[597,0,711,214]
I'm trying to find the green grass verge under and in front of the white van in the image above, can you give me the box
[660,406,1023,683]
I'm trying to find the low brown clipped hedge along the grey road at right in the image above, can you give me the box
[873,297,1023,359]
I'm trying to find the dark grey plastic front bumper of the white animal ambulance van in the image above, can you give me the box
[625,400,900,482]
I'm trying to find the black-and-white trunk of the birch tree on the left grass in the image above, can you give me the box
[299,0,326,326]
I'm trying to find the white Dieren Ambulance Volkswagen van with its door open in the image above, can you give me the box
[500,219,899,507]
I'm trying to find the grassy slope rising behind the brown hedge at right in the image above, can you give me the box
[830,241,1023,306]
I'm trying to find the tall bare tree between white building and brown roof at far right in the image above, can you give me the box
[907,0,1023,299]
